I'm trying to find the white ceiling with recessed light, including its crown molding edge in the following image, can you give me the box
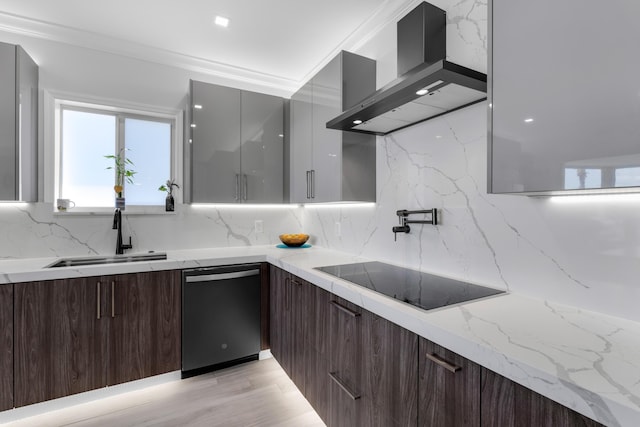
[0,0,416,92]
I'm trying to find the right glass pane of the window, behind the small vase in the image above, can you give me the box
[124,118,171,205]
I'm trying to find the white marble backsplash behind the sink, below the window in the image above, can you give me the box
[0,203,303,259]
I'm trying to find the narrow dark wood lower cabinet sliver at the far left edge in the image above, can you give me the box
[0,285,13,411]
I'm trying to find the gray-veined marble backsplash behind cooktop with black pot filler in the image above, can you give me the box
[304,103,640,320]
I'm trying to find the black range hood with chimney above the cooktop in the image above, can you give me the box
[327,2,487,135]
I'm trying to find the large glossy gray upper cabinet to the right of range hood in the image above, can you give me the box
[489,0,640,194]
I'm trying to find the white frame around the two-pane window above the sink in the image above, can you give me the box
[46,92,184,215]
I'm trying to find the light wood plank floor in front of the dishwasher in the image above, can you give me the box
[7,359,324,427]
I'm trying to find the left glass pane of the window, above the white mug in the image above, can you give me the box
[60,110,116,207]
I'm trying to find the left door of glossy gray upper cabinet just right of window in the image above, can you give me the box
[191,81,242,203]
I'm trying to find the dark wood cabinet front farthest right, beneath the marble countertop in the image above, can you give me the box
[481,368,602,427]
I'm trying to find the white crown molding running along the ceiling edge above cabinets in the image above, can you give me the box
[0,0,420,94]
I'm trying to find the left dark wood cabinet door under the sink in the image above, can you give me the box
[14,278,108,407]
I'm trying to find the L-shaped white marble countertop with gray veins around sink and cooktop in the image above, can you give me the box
[0,246,640,426]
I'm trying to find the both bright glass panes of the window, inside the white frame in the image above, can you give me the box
[57,102,177,210]
